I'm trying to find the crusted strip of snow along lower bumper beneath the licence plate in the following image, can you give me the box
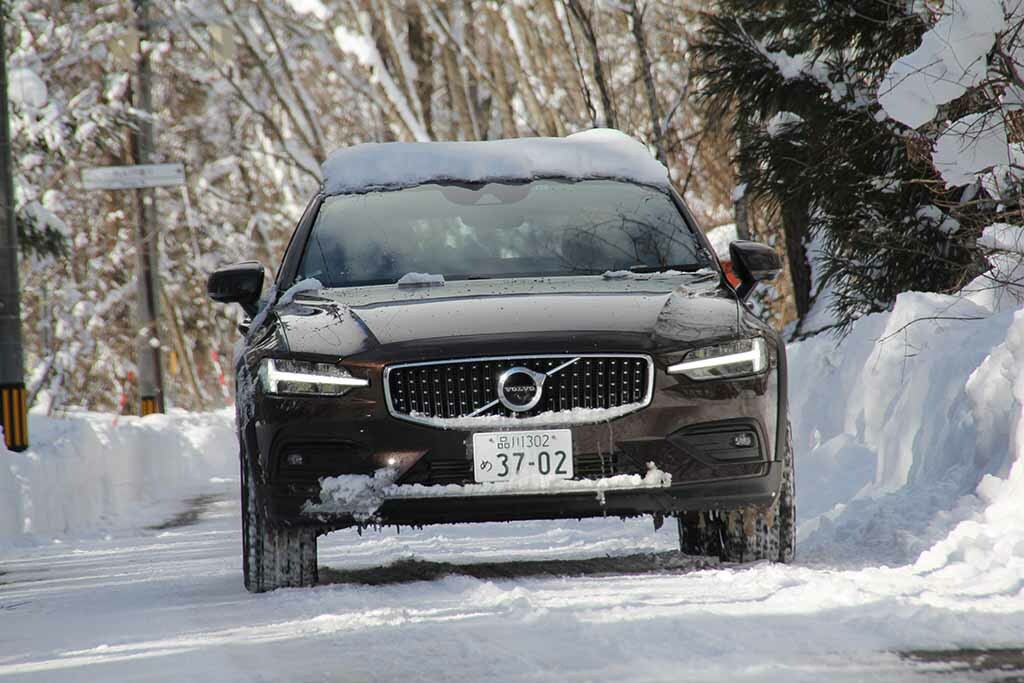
[302,463,672,522]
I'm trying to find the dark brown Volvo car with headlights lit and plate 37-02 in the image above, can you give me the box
[209,135,794,591]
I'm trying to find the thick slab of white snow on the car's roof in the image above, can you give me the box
[323,128,669,195]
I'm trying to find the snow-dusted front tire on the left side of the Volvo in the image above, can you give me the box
[242,450,317,593]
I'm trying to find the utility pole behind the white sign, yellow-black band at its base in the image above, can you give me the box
[133,0,164,416]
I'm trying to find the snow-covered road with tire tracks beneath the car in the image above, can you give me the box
[0,482,1024,681]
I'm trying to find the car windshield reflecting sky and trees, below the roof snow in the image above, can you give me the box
[296,179,709,287]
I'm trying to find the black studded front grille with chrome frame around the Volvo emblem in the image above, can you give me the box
[385,354,653,420]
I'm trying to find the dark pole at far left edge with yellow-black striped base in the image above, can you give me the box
[0,13,29,451]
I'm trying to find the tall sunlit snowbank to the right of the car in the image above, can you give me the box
[790,226,1024,569]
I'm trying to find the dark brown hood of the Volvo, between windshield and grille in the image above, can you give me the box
[264,273,744,359]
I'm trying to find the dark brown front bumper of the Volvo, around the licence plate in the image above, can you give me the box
[246,350,784,529]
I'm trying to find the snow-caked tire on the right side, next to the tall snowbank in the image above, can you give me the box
[678,423,797,563]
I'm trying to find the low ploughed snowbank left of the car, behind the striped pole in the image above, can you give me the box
[0,411,238,544]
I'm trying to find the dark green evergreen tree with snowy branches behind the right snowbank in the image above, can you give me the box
[695,0,994,334]
